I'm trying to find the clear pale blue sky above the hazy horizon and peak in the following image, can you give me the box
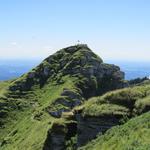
[0,0,150,61]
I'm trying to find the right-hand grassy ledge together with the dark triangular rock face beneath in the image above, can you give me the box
[75,84,150,146]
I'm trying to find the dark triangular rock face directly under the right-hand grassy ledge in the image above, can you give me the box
[77,115,122,147]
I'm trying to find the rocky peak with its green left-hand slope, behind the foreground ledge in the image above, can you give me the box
[0,45,126,150]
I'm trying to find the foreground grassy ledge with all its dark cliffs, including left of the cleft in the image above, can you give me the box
[45,80,150,150]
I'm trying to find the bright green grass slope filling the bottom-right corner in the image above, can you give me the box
[81,112,150,150]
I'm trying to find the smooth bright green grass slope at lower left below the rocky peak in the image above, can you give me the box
[0,77,73,150]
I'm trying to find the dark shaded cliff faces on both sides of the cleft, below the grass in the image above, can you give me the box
[44,114,123,150]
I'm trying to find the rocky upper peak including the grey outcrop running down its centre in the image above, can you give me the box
[7,44,125,117]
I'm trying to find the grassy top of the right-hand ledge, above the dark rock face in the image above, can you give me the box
[78,83,150,118]
